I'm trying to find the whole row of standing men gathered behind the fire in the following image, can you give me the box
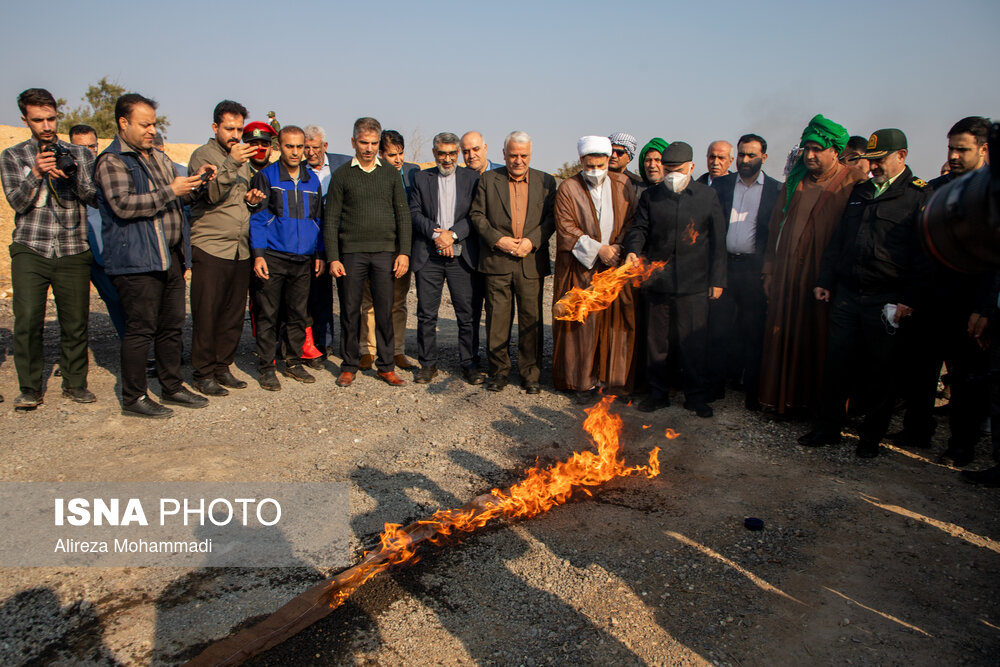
[0,88,1000,483]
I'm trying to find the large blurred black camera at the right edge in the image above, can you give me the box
[919,123,1000,273]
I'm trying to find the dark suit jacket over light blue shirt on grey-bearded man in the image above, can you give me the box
[410,167,479,271]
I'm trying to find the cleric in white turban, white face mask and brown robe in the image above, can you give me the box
[552,136,636,402]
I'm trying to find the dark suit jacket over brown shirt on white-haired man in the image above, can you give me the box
[469,167,556,278]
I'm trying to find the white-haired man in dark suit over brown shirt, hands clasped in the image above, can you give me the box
[469,132,556,394]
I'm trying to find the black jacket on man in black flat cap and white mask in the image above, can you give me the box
[622,182,726,298]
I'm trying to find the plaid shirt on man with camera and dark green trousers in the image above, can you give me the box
[0,137,97,259]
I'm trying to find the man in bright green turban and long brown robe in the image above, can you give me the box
[760,115,868,414]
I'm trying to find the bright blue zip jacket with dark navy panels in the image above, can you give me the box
[250,160,323,261]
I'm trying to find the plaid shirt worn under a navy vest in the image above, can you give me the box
[94,135,193,248]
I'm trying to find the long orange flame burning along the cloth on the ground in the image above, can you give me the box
[319,396,676,607]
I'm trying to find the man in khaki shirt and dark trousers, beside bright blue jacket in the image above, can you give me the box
[188,100,263,396]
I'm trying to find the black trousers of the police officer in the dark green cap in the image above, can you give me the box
[820,285,900,443]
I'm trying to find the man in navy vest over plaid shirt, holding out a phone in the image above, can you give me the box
[93,93,216,419]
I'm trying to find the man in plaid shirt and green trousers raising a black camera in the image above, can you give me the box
[0,88,96,409]
